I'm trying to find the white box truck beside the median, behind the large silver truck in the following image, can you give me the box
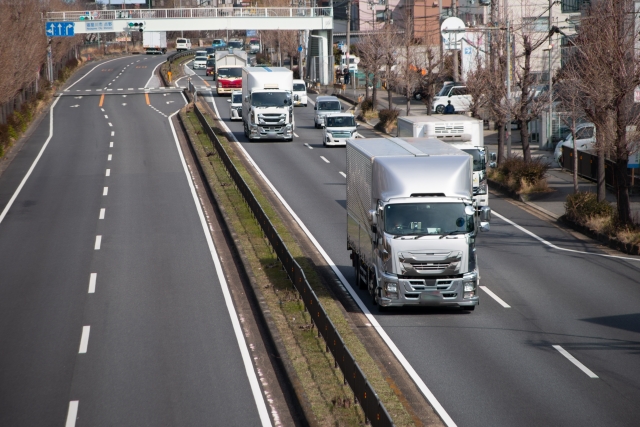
[242,67,295,141]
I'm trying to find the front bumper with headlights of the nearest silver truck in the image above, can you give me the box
[377,272,479,307]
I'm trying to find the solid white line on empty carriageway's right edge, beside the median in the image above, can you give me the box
[169,112,271,426]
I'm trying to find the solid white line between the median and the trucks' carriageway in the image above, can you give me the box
[208,93,456,427]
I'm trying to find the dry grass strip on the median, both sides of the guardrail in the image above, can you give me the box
[181,104,414,426]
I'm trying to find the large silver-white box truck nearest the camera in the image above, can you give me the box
[346,138,491,310]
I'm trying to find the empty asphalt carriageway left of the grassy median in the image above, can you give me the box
[0,56,271,426]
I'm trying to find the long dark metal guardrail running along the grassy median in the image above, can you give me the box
[188,103,394,427]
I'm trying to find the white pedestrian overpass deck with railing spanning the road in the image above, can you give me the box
[43,7,333,34]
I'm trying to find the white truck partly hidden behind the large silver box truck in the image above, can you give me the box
[398,114,489,207]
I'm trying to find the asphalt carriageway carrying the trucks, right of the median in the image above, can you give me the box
[194,66,640,426]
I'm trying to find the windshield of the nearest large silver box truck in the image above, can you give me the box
[384,203,474,236]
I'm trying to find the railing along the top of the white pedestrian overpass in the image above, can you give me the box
[43,7,333,21]
